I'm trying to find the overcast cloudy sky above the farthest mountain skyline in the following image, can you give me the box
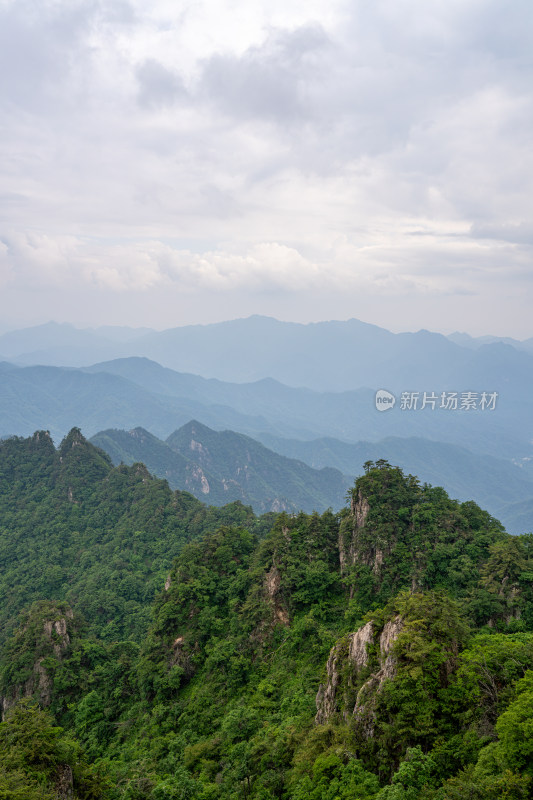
[0,0,533,338]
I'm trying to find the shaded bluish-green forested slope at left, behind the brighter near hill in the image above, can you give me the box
[0,428,266,640]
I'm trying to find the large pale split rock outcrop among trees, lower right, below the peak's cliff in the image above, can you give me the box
[315,616,403,736]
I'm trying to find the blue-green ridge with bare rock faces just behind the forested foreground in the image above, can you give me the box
[91,420,351,513]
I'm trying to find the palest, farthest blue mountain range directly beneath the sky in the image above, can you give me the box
[0,315,533,392]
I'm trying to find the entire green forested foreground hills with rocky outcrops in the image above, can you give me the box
[0,429,533,800]
